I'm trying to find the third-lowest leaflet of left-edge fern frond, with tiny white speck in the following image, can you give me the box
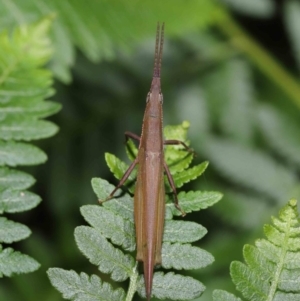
[0,189,41,213]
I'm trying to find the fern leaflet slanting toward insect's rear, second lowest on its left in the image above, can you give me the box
[75,226,135,281]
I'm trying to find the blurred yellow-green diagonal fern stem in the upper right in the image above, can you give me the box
[217,10,300,109]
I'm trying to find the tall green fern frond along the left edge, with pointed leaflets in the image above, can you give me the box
[0,17,60,277]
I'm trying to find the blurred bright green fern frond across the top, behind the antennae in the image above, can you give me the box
[0,0,216,82]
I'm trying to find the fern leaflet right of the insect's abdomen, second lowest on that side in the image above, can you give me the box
[161,243,214,270]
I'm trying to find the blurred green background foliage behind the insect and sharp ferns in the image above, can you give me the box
[0,0,300,301]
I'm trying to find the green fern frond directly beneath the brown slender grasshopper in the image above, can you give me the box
[48,125,222,300]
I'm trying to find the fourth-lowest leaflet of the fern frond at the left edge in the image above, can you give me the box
[0,167,35,190]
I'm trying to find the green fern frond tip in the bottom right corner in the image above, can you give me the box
[214,199,300,301]
